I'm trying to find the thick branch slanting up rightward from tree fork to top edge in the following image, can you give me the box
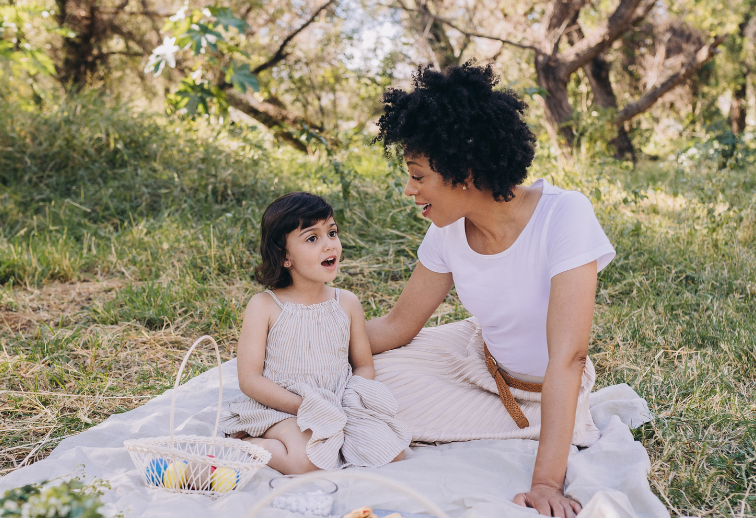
[555,0,656,82]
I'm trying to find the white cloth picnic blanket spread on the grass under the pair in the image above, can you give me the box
[0,360,669,518]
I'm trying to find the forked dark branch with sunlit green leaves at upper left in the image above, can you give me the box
[145,0,336,152]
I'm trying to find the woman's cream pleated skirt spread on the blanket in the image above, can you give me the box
[373,317,601,446]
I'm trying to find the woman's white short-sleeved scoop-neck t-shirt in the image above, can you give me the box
[417,179,615,376]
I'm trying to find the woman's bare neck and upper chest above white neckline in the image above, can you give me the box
[465,185,542,255]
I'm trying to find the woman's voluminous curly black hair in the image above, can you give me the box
[373,61,536,201]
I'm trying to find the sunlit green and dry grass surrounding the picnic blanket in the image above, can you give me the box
[0,94,756,516]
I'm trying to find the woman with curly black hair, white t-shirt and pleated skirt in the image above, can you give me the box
[367,63,614,517]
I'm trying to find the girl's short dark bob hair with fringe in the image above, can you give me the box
[255,192,333,289]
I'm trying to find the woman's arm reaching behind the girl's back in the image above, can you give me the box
[365,261,454,354]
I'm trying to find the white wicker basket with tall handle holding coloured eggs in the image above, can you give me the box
[123,336,270,498]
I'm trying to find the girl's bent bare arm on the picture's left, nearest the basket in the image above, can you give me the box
[236,293,302,415]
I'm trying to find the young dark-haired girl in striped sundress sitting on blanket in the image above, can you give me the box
[221,192,410,475]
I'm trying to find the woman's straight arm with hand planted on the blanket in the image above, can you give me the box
[514,261,598,518]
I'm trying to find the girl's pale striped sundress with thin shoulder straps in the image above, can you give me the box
[221,290,410,469]
